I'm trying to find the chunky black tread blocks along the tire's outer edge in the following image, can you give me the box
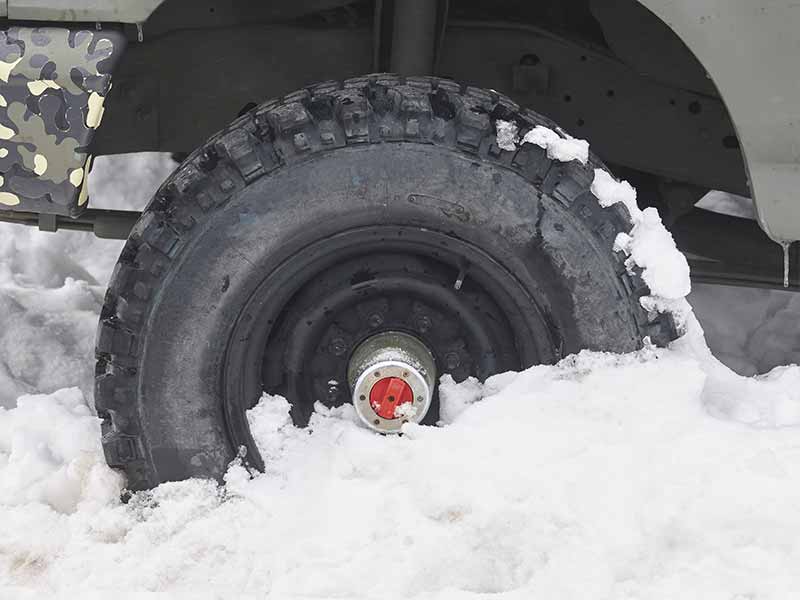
[95,74,677,491]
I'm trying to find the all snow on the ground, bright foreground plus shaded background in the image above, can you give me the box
[0,156,800,600]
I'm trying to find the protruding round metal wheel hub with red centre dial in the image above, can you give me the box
[348,331,436,433]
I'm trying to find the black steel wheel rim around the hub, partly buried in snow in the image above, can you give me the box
[222,225,561,469]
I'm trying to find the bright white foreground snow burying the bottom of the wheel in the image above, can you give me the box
[0,338,800,600]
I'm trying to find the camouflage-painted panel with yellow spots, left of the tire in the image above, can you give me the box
[0,27,126,216]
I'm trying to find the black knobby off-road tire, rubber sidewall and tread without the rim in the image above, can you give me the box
[95,75,676,490]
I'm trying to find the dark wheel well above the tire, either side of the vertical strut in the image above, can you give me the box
[95,0,747,194]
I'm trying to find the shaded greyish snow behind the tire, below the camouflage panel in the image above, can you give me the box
[0,153,174,407]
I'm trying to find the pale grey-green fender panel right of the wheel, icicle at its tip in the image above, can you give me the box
[639,0,800,242]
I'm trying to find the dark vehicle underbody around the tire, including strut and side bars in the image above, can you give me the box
[0,0,800,288]
